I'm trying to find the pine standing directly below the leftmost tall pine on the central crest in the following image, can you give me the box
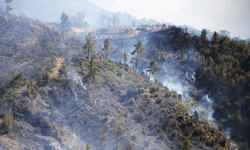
[82,56,102,95]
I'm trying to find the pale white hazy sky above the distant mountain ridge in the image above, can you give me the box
[89,0,250,39]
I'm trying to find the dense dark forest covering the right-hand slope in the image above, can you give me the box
[158,26,250,149]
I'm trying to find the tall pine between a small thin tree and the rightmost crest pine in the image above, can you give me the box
[130,39,147,70]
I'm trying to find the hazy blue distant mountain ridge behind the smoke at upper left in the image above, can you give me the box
[0,0,158,26]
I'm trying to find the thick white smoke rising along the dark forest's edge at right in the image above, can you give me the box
[157,60,216,125]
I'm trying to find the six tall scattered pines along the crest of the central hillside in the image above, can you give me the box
[82,33,159,96]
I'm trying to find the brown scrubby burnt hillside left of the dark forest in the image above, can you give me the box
[0,14,240,150]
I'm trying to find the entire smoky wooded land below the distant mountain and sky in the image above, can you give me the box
[0,0,250,150]
